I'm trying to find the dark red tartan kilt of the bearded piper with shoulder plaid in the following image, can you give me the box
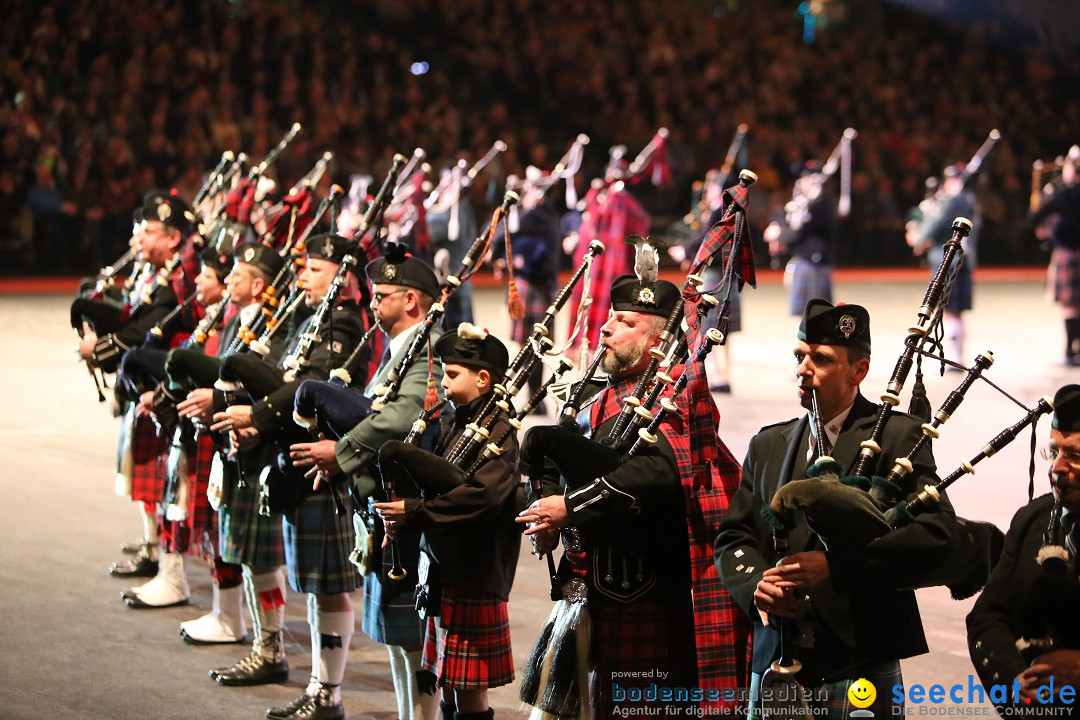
[588,584,698,718]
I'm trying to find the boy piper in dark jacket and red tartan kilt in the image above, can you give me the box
[375,323,521,720]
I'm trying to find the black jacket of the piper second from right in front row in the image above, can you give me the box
[715,395,955,685]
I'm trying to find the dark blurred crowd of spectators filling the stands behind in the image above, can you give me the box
[0,0,1080,274]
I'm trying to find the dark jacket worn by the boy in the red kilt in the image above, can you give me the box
[405,396,522,600]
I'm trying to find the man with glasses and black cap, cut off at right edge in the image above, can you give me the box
[968,385,1080,715]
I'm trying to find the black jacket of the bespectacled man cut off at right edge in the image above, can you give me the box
[968,494,1080,693]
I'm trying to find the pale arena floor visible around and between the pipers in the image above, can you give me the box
[0,273,1080,720]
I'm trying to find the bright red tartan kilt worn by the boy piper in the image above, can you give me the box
[423,585,514,690]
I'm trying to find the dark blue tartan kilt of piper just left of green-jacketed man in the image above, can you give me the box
[282,476,360,595]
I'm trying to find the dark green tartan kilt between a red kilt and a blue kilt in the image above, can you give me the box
[217,455,285,568]
